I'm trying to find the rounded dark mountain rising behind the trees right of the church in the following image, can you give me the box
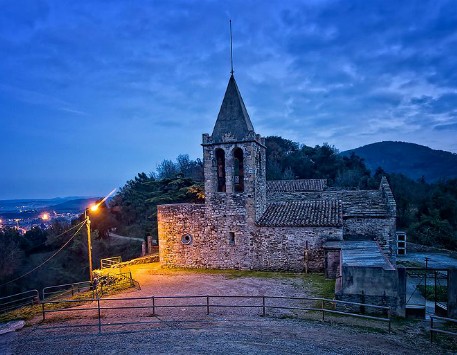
[340,141,457,182]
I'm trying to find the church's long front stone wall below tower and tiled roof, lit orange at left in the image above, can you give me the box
[157,202,343,272]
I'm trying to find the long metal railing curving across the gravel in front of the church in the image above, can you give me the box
[42,295,391,333]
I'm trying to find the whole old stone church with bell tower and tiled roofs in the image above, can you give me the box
[157,74,396,277]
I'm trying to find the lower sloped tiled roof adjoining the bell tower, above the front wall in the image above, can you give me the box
[258,200,343,227]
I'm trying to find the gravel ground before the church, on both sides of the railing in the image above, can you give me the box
[0,265,450,354]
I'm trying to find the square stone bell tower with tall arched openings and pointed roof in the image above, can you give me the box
[202,73,266,223]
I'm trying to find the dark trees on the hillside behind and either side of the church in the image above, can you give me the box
[0,136,457,295]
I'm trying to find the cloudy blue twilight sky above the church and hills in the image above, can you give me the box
[0,0,457,199]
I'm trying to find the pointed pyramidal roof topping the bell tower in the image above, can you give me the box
[212,74,254,142]
